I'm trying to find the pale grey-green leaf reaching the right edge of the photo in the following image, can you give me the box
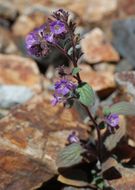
[110,101,135,115]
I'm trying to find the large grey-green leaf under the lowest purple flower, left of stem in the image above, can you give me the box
[56,143,86,168]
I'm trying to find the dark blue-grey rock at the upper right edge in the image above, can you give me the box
[112,18,135,68]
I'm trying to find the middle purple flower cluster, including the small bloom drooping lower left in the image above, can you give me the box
[52,77,77,106]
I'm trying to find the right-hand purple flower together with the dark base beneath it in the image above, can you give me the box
[105,113,119,133]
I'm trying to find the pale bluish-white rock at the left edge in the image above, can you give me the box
[0,85,34,109]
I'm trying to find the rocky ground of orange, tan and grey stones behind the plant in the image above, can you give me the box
[0,0,135,190]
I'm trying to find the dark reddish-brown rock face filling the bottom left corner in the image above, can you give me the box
[0,148,53,190]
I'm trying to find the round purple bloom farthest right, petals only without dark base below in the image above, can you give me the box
[105,113,119,127]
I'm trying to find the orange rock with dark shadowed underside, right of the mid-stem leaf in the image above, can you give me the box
[80,68,116,96]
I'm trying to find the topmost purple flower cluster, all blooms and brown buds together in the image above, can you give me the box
[25,10,67,57]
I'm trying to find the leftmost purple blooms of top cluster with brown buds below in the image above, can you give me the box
[25,26,49,57]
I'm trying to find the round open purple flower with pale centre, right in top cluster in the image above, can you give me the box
[50,20,66,35]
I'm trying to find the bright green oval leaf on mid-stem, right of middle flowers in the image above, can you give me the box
[76,82,95,106]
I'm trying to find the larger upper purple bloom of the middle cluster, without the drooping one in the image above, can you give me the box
[54,79,76,96]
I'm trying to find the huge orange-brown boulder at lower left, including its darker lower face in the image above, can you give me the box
[0,95,88,190]
